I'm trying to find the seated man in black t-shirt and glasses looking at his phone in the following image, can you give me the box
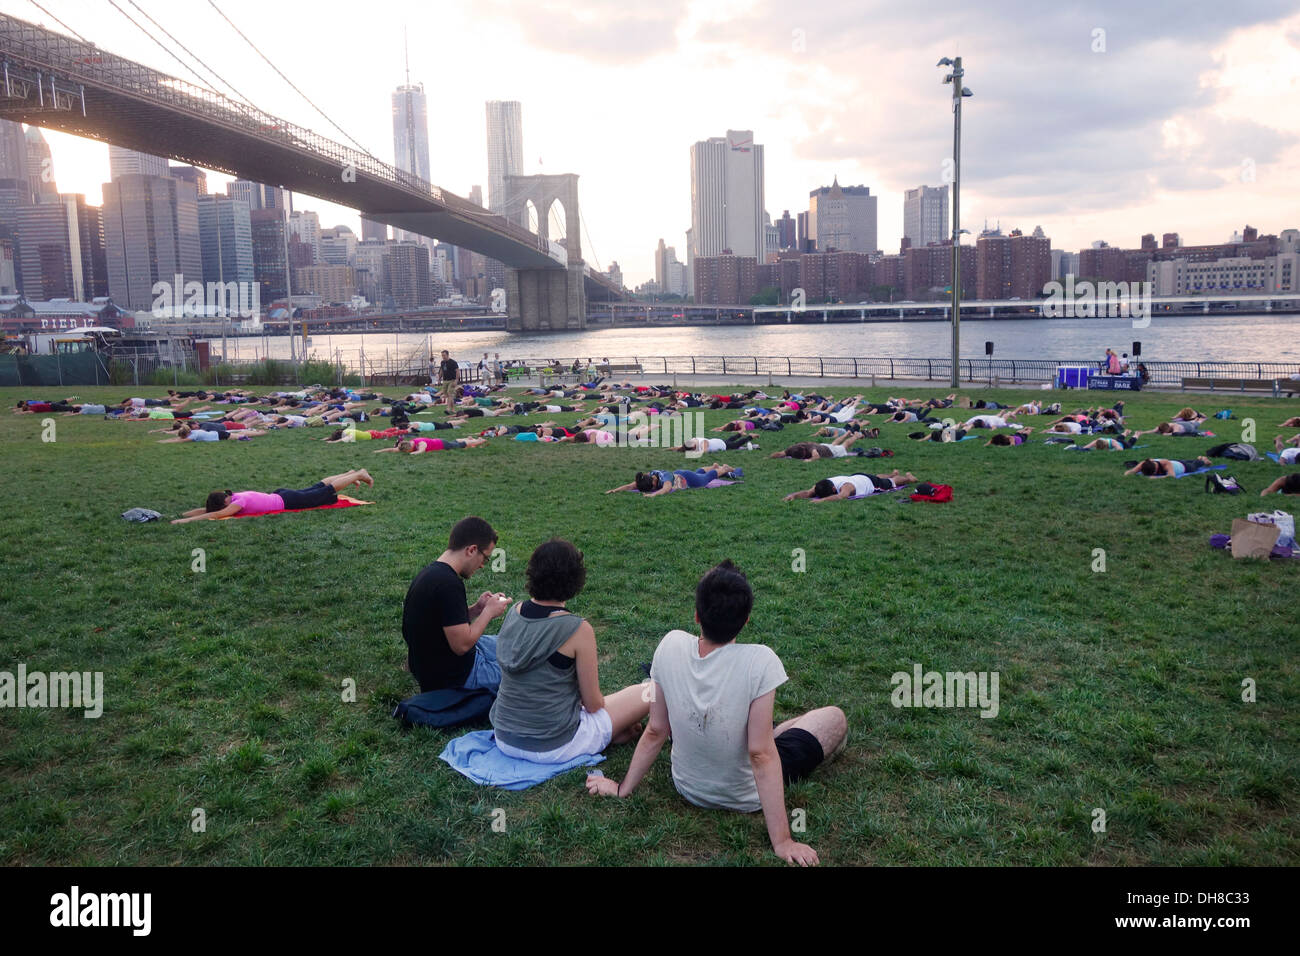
[402,518,511,693]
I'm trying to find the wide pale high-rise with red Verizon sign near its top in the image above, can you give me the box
[688,130,764,265]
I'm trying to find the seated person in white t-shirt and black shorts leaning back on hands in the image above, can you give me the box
[586,561,849,866]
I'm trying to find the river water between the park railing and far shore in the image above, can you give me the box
[215,312,1300,367]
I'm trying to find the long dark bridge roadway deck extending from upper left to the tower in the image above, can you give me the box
[0,14,615,303]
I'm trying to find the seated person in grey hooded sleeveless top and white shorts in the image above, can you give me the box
[490,538,650,763]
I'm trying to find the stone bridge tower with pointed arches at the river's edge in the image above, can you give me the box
[504,173,586,332]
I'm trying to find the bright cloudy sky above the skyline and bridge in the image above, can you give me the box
[0,0,1300,286]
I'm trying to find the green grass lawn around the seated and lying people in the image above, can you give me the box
[0,384,1300,865]
